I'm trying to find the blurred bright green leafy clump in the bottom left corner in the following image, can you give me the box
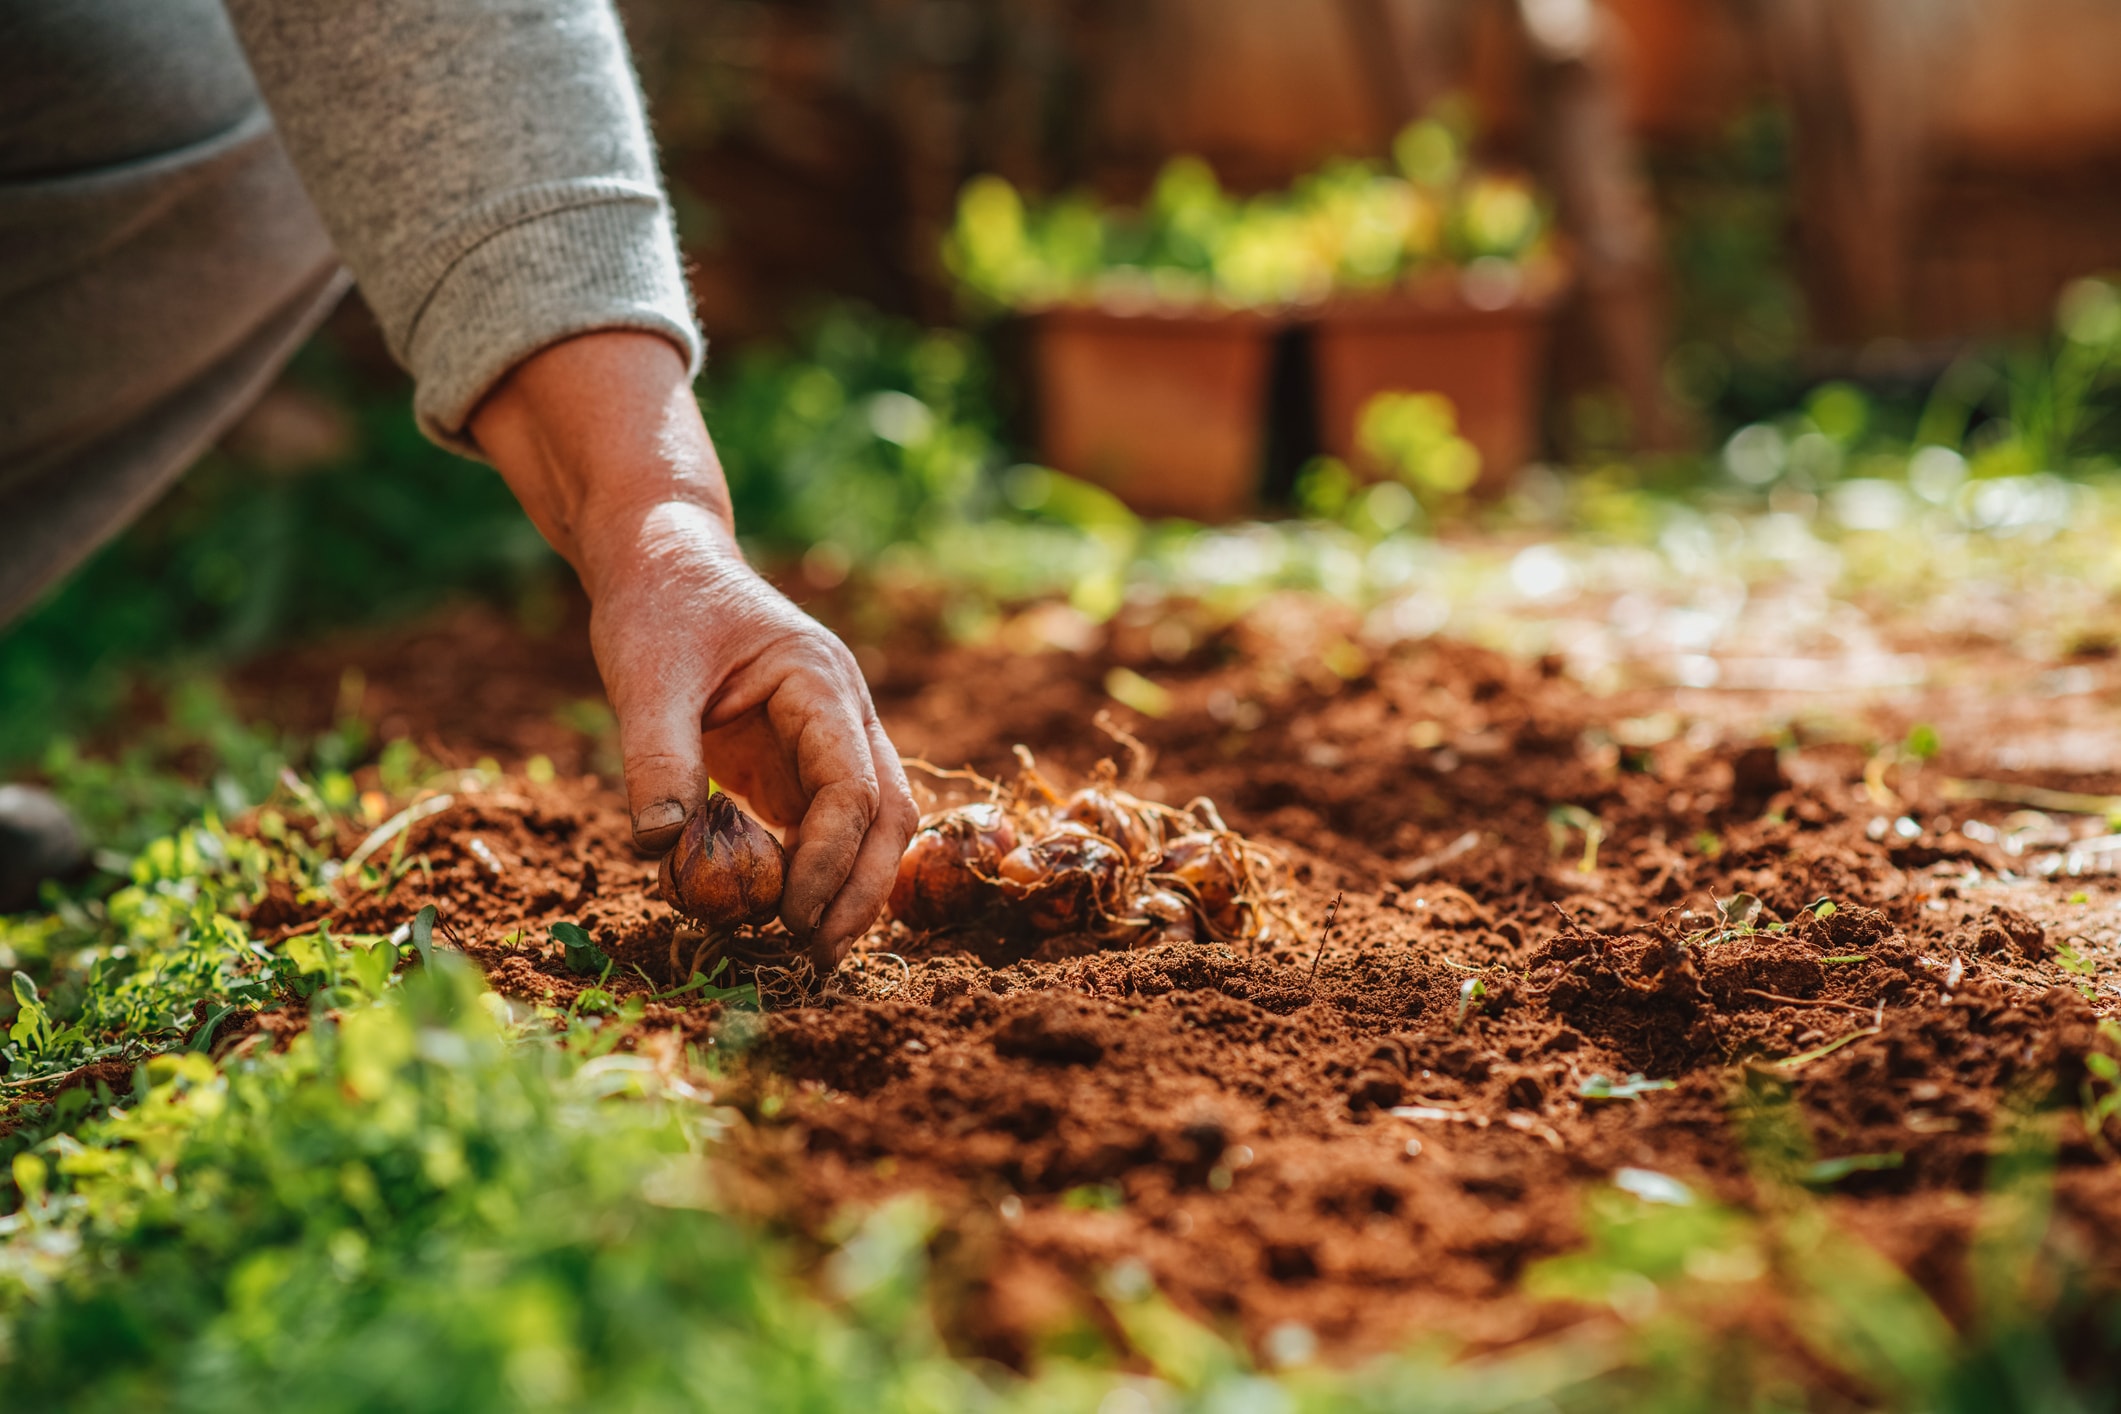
[0,956,1001,1412]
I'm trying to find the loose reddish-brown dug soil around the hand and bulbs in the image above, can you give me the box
[232,604,2121,1361]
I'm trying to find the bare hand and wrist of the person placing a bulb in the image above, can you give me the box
[471,331,916,971]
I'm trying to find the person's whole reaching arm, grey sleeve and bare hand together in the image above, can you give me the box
[229,0,914,962]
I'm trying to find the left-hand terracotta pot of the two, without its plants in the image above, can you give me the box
[1031,310,1275,522]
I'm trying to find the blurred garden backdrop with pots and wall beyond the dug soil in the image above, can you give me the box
[0,0,2121,774]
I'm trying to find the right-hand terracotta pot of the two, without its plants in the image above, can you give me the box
[1313,295,1553,492]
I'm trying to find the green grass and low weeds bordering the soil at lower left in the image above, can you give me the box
[0,746,1589,1414]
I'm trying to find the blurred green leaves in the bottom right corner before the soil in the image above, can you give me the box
[1525,1079,2121,1414]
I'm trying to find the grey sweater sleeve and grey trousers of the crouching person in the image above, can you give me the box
[0,0,702,621]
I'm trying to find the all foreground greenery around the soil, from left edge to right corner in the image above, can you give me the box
[0,695,2121,1414]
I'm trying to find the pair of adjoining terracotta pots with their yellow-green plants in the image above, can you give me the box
[946,119,1559,519]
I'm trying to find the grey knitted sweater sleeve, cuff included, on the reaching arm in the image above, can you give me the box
[229,0,702,452]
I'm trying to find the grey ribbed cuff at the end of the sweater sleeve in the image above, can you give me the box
[405,180,704,456]
